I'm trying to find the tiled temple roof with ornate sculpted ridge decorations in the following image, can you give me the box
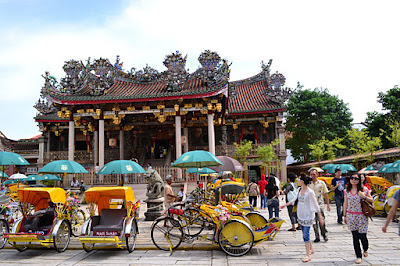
[35,50,290,122]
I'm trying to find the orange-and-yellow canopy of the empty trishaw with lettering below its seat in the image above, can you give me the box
[85,187,135,215]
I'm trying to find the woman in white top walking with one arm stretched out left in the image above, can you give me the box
[280,174,324,262]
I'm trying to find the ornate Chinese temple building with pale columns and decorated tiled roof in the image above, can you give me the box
[35,50,290,181]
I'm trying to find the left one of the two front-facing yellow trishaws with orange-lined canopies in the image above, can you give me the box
[4,188,71,252]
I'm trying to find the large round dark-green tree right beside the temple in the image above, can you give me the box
[286,84,353,162]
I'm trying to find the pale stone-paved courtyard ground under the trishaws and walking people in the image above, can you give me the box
[0,185,400,266]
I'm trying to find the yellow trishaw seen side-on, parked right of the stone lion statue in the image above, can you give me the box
[151,180,284,256]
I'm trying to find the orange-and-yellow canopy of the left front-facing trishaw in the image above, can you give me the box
[18,187,67,211]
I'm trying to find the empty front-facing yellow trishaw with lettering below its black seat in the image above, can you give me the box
[79,187,140,252]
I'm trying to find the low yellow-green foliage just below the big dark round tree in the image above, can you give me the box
[309,136,347,161]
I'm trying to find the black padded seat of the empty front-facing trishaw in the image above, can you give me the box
[93,209,126,231]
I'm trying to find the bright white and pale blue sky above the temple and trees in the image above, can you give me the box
[0,0,400,139]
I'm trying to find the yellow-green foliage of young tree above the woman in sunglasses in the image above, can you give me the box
[347,128,382,168]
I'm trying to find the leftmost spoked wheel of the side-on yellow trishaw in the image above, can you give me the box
[151,217,183,251]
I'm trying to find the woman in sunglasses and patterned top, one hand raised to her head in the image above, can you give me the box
[343,174,373,264]
